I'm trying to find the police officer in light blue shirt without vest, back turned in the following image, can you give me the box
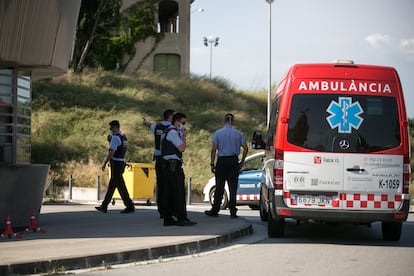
[205,113,248,218]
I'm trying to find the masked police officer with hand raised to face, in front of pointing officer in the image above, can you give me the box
[161,113,196,226]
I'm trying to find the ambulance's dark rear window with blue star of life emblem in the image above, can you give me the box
[287,94,401,152]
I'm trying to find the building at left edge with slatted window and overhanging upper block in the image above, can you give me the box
[0,0,81,231]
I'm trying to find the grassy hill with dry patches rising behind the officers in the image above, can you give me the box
[32,71,267,196]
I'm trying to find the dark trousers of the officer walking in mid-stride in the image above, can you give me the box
[101,160,134,209]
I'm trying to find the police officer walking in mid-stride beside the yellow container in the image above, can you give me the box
[95,120,135,214]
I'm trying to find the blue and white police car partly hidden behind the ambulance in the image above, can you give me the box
[203,151,265,209]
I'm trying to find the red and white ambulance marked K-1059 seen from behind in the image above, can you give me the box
[252,61,411,241]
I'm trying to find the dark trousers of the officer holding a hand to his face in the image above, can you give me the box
[162,160,187,221]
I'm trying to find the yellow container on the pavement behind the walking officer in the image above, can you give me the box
[109,163,155,205]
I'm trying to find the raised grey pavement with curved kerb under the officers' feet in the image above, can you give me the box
[0,203,253,275]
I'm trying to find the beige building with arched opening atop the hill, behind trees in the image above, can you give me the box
[122,0,194,75]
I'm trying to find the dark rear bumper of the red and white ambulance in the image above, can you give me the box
[270,193,410,223]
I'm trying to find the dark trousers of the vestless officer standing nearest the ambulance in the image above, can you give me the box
[212,156,240,214]
